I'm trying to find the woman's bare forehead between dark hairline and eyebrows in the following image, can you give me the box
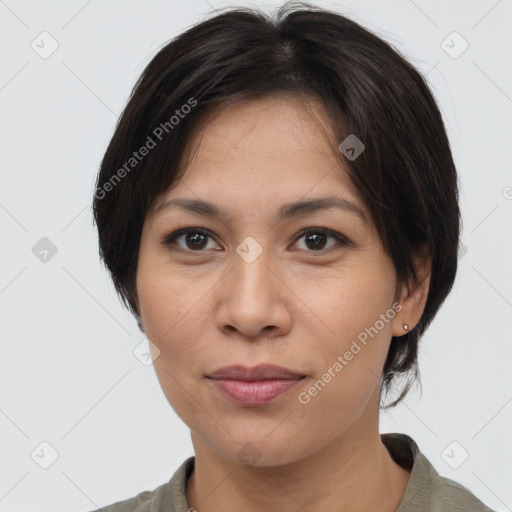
[150,94,363,219]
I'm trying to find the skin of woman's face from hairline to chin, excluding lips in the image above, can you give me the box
[136,96,404,466]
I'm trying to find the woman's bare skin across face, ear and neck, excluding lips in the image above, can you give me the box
[136,95,430,512]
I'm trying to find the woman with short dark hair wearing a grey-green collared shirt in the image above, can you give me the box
[94,4,491,512]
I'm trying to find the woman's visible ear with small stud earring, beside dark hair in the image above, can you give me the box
[392,257,432,336]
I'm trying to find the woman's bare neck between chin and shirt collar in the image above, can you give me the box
[186,412,410,512]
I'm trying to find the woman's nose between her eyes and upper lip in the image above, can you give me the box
[216,243,293,339]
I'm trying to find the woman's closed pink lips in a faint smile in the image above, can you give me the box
[207,364,305,405]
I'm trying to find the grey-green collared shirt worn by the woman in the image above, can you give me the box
[89,434,495,512]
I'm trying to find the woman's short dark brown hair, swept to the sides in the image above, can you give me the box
[93,2,460,407]
